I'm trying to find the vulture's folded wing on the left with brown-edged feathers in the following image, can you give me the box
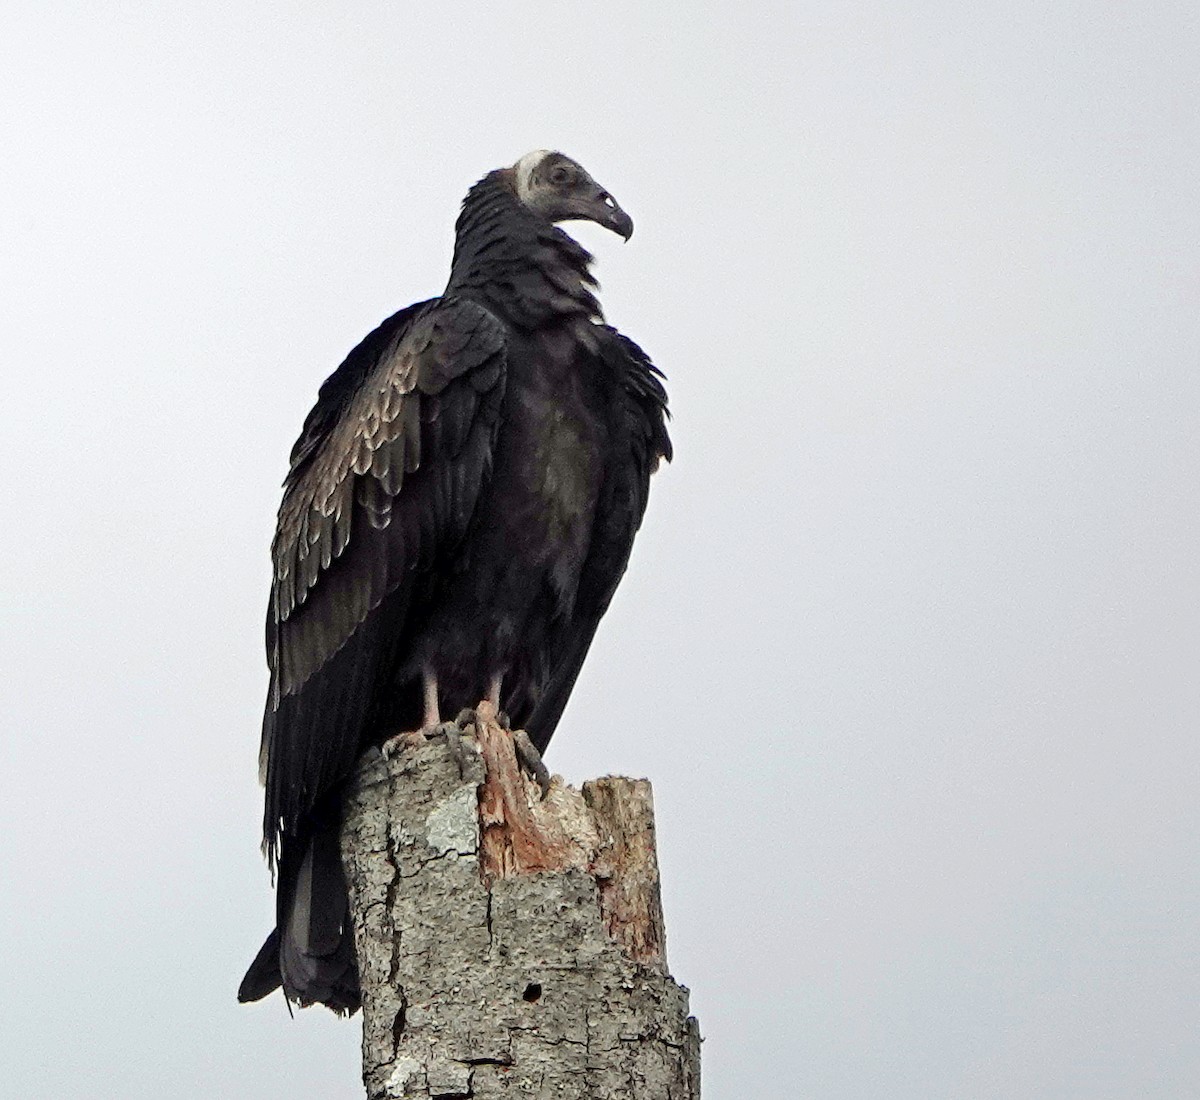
[262,297,505,853]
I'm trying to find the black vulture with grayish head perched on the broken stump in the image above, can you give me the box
[238,150,671,1011]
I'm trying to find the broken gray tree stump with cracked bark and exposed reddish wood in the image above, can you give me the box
[342,704,700,1100]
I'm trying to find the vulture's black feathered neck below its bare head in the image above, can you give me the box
[445,169,600,327]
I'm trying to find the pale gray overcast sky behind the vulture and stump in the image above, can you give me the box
[0,0,1200,1100]
